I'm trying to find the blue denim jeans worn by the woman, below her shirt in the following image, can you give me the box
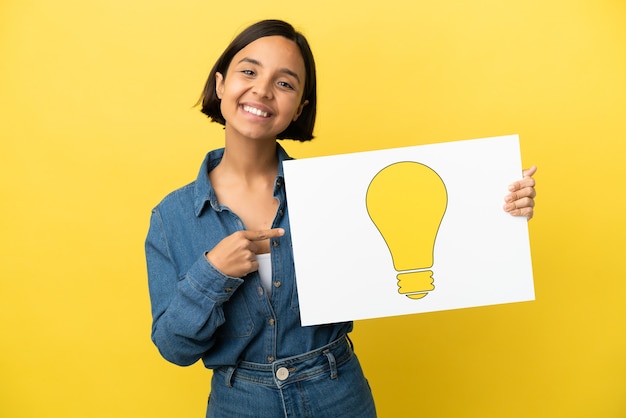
[206,337,376,418]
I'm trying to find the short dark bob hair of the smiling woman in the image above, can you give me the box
[198,20,317,141]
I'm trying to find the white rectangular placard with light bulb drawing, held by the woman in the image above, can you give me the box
[284,135,534,326]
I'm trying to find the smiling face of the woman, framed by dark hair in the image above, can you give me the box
[216,36,307,140]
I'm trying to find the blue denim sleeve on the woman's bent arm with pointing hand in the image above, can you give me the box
[145,208,243,366]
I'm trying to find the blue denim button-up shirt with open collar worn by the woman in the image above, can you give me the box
[146,145,352,368]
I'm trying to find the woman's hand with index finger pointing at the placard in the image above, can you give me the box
[206,228,285,277]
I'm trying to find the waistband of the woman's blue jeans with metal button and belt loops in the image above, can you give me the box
[214,335,353,387]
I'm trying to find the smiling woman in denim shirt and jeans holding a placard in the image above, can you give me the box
[146,20,535,418]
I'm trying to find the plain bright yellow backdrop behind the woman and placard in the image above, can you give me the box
[0,0,626,418]
